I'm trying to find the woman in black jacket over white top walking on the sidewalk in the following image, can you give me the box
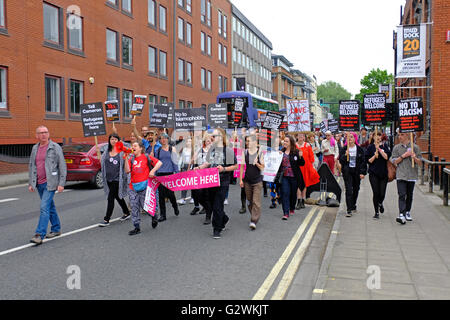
[339,132,367,217]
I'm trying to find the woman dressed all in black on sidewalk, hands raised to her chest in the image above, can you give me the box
[366,132,391,219]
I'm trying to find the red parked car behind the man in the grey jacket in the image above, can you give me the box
[62,143,107,188]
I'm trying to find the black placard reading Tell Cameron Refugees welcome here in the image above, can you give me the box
[80,102,106,137]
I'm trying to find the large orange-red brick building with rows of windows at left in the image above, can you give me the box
[0,0,232,174]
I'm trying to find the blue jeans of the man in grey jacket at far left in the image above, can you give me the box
[36,183,61,239]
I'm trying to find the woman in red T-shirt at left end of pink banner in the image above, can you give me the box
[125,141,162,236]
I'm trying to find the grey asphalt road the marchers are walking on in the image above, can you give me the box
[0,183,337,300]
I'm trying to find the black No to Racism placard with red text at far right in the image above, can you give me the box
[398,97,423,133]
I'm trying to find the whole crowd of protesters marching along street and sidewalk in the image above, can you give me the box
[29,120,421,244]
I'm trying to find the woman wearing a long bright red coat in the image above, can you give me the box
[295,133,320,210]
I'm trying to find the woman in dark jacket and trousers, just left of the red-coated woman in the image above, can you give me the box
[277,136,305,220]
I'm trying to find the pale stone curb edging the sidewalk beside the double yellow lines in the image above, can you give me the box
[311,182,345,300]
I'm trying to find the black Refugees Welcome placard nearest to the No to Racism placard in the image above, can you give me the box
[362,93,386,126]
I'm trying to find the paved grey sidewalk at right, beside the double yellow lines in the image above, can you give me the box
[312,177,450,300]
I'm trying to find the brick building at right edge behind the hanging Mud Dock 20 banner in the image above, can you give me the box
[396,0,450,161]
